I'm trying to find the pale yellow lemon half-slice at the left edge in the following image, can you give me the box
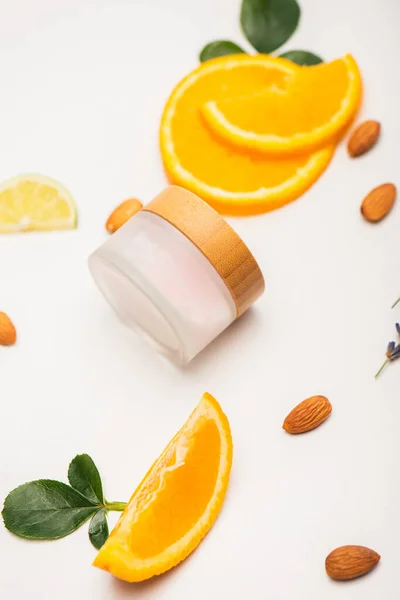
[0,174,77,233]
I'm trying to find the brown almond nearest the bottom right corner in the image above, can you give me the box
[325,546,381,581]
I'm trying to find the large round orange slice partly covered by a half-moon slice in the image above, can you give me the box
[160,54,334,214]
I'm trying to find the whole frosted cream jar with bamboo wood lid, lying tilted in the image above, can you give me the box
[89,186,264,363]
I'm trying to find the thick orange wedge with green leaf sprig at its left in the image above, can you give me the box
[93,394,232,582]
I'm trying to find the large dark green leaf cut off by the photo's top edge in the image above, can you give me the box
[240,0,300,54]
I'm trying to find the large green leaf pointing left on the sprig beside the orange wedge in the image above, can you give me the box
[2,479,98,540]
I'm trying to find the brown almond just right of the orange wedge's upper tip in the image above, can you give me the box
[282,396,332,434]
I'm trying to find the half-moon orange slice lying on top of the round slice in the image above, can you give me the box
[202,55,361,154]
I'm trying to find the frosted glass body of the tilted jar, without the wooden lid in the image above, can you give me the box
[89,211,237,363]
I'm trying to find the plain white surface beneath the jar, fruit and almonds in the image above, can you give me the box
[0,0,400,600]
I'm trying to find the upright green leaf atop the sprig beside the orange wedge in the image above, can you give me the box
[68,454,104,505]
